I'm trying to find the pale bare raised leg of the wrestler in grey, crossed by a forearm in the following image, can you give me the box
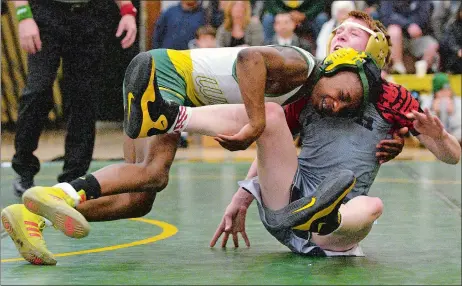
[186,103,298,210]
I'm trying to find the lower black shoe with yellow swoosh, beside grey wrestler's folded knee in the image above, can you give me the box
[265,170,356,234]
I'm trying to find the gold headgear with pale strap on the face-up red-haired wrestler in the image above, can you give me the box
[327,20,390,68]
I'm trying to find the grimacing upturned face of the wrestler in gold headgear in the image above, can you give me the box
[329,17,370,53]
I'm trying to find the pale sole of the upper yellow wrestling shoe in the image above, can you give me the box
[22,190,90,238]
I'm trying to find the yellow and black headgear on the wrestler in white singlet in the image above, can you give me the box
[319,48,382,113]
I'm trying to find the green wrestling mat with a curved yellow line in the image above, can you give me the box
[0,161,461,285]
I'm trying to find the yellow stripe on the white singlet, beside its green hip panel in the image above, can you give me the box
[167,50,205,106]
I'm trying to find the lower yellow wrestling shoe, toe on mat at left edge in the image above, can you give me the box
[2,204,56,265]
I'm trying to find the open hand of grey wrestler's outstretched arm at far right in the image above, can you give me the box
[406,108,446,139]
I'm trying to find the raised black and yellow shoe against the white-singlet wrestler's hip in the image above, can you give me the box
[124,52,178,139]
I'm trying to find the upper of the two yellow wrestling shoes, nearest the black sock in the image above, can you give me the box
[22,186,90,238]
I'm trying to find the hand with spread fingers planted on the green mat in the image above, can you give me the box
[210,192,250,247]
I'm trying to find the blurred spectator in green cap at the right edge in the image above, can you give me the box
[431,73,462,143]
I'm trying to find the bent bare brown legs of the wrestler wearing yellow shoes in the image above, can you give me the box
[76,134,179,221]
